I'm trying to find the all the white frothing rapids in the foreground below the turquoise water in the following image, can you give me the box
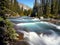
[21,31,60,45]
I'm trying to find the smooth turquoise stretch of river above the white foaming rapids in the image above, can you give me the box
[9,18,60,34]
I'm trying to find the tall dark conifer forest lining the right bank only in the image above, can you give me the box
[31,0,60,19]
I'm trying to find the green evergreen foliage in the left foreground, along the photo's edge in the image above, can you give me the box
[0,0,18,45]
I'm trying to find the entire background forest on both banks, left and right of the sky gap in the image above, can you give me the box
[0,0,60,19]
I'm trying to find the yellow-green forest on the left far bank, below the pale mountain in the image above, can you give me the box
[2,0,31,17]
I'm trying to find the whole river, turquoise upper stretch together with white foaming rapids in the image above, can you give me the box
[8,19,60,45]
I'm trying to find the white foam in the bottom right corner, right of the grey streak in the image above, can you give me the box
[40,31,60,45]
